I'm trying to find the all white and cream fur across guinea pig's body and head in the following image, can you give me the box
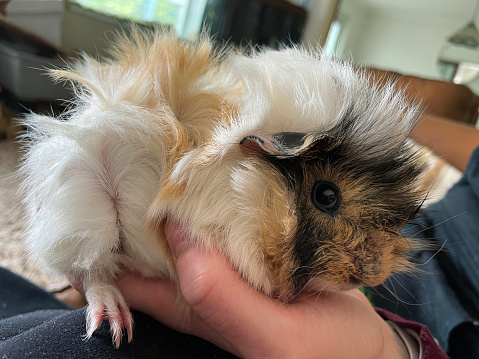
[21,34,415,346]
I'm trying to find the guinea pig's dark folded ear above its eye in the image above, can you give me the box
[239,132,306,157]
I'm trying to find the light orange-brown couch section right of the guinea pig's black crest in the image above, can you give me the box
[411,114,479,171]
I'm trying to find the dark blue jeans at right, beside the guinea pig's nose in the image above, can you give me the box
[368,148,479,359]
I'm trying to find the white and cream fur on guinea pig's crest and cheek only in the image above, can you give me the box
[155,48,417,294]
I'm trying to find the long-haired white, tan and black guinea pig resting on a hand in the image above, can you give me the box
[21,29,423,346]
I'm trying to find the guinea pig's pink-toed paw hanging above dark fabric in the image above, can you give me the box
[85,284,133,348]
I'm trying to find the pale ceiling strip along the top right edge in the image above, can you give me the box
[352,0,478,22]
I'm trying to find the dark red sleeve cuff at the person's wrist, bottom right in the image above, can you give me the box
[376,308,449,359]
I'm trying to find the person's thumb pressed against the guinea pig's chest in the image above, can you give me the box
[165,222,285,354]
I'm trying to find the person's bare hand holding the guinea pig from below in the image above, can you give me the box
[117,222,408,359]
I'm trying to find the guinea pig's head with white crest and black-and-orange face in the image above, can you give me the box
[150,44,423,301]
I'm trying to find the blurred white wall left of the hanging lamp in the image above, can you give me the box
[339,0,479,78]
